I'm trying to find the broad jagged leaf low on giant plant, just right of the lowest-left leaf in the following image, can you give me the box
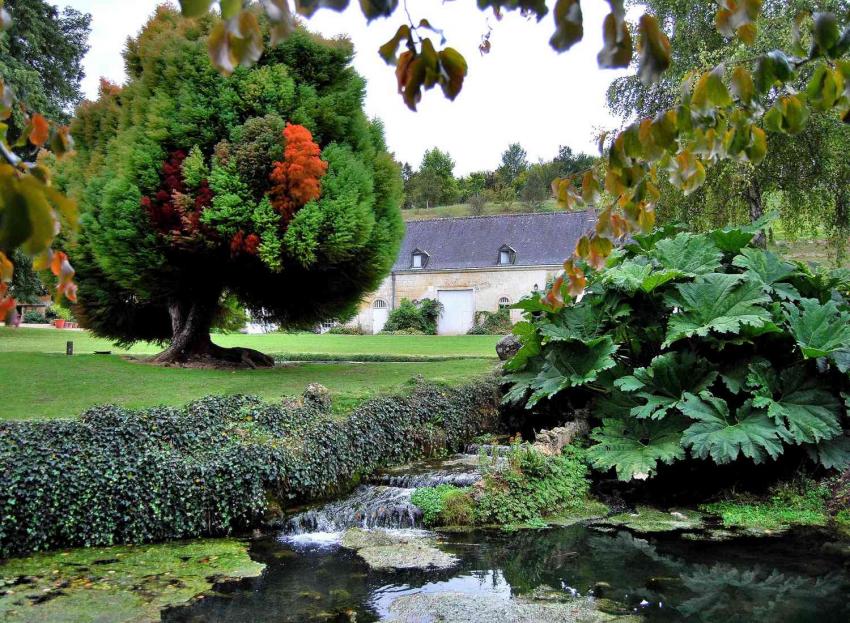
[679,392,783,465]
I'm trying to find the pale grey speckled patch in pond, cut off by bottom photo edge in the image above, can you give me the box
[383,592,640,623]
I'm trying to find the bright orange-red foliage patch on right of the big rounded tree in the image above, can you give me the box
[269,123,328,225]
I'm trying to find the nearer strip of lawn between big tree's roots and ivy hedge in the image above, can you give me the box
[0,352,494,419]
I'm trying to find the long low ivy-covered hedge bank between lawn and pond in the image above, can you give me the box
[0,380,499,557]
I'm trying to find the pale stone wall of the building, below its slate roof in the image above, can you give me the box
[348,266,561,333]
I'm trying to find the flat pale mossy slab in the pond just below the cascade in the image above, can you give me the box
[341,528,458,571]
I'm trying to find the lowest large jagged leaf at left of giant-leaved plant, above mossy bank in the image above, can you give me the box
[587,418,685,480]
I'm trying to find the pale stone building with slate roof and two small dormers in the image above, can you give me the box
[348,211,596,335]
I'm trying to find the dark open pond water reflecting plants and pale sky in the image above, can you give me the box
[164,526,850,623]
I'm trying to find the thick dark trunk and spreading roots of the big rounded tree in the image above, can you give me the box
[152,295,274,368]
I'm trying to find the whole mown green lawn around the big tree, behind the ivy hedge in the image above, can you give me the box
[0,327,498,419]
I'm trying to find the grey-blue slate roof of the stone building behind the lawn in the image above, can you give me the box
[393,210,596,271]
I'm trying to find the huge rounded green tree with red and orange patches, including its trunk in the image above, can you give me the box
[57,7,403,365]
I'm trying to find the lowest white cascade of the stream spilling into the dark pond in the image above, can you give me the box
[284,485,422,535]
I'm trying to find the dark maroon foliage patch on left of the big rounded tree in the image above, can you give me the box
[141,149,213,239]
